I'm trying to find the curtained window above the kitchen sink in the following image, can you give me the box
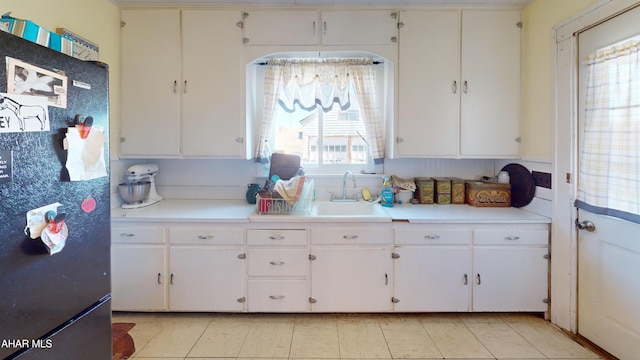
[247,53,394,174]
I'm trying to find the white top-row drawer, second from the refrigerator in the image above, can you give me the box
[169,227,243,245]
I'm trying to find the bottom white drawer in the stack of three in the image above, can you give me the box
[247,280,308,312]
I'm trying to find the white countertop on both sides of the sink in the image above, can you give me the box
[111,199,551,224]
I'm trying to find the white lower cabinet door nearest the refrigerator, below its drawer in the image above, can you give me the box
[111,244,168,311]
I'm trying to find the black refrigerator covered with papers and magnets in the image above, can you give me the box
[0,31,112,360]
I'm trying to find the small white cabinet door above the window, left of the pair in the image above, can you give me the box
[243,10,320,45]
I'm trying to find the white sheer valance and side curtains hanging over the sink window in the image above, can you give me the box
[256,59,384,164]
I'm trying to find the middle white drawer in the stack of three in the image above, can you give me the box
[248,248,309,276]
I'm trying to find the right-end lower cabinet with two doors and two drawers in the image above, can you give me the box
[393,225,549,312]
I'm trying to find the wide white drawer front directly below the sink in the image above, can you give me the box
[311,227,393,245]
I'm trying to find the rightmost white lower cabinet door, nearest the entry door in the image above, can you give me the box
[473,246,549,312]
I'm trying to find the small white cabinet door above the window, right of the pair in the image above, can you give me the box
[322,10,398,45]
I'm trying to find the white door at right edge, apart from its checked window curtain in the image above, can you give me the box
[577,8,640,359]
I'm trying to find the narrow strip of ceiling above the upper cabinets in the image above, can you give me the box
[111,0,534,8]
